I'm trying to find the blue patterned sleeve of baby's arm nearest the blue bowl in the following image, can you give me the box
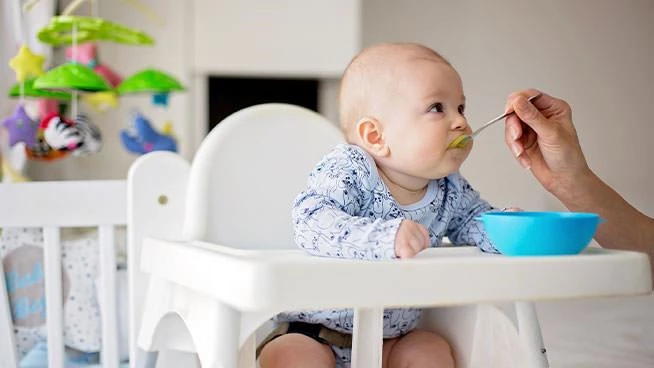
[447,174,497,253]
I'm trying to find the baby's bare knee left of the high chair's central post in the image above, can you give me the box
[259,333,336,368]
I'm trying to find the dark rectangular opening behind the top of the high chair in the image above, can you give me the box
[208,76,318,131]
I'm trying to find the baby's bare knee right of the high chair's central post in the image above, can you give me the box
[383,330,455,368]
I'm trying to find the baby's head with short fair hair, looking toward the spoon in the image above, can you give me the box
[339,43,472,180]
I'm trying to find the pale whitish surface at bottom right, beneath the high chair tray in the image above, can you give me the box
[538,296,654,368]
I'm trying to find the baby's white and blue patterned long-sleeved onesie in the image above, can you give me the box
[277,144,496,366]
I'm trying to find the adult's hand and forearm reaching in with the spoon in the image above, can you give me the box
[504,90,654,278]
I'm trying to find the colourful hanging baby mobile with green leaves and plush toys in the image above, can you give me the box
[0,0,184,165]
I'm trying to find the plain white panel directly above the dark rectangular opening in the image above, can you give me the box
[190,0,361,78]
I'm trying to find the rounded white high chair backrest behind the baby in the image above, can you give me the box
[184,103,343,249]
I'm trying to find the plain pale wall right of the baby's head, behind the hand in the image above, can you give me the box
[363,0,654,215]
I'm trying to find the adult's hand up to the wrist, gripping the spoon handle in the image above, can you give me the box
[504,89,590,192]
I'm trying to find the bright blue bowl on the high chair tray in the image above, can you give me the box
[478,212,603,256]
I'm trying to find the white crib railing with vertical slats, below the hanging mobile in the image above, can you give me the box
[0,180,127,367]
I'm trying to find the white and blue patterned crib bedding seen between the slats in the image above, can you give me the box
[0,228,127,362]
